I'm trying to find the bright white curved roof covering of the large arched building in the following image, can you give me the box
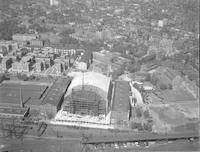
[67,72,111,98]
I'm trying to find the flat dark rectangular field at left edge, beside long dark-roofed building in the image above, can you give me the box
[0,81,50,106]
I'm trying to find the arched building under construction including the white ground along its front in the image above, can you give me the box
[52,72,112,128]
